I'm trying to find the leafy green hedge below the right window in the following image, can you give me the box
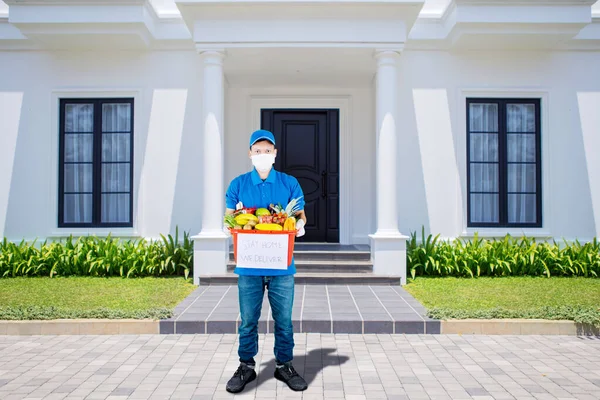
[407,230,600,279]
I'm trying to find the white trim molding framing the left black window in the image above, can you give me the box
[46,87,144,238]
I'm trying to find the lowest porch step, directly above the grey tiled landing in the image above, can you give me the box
[200,272,400,286]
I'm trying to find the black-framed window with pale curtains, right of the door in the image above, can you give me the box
[467,98,542,227]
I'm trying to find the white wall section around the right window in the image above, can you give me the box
[399,51,600,244]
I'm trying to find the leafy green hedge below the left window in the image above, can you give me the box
[0,230,194,279]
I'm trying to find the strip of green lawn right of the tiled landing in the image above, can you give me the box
[405,277,600,326]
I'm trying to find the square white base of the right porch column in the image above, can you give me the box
[369,231,409,285]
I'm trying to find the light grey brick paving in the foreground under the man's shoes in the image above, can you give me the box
[0,334,600,400]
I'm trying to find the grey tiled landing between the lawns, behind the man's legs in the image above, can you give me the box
[160,285,440,334]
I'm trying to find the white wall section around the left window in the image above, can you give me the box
[0,51,202,240]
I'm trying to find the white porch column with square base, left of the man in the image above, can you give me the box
[193,50,228,284]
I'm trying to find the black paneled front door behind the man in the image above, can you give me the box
[261,109,340,243]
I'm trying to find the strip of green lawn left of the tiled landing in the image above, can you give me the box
[0,277,195,319]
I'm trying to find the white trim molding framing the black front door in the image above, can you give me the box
[248,94,352,244]
